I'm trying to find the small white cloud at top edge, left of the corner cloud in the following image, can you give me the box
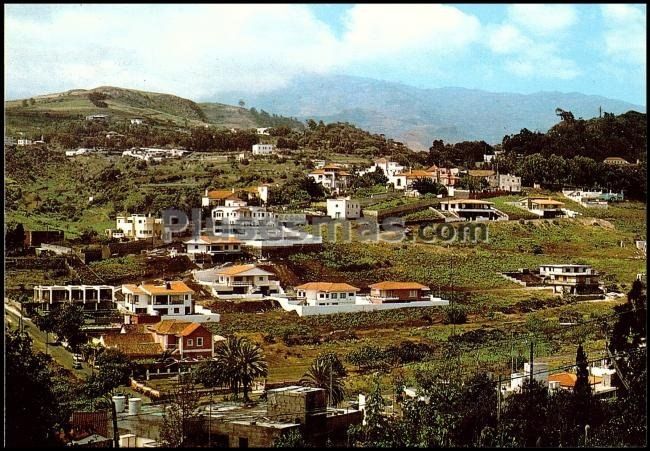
[508,4,577,35]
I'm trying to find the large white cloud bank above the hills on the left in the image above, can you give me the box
[5,4,480,99]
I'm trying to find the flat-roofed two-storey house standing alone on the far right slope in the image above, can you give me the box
[539,264,602,294]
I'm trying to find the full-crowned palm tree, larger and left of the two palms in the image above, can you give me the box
[215,337,268,402]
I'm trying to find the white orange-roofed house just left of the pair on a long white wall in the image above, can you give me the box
[212,264,283,298]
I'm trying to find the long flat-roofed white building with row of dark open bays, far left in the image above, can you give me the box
[34,285,117,312]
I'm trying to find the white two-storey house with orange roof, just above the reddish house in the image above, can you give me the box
[122,281,194,318]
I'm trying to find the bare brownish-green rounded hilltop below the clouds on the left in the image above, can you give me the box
[5,86,301,135]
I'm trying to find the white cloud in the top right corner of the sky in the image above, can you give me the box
[601,5,646,66]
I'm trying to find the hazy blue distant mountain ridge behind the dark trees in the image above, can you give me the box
[214,75,646,149]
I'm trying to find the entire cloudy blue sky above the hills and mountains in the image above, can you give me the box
[4,3,646,106]
